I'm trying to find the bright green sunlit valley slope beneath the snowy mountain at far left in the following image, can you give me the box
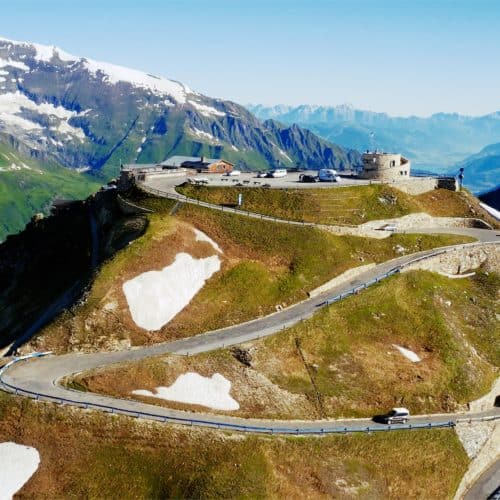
[0,144,101,241]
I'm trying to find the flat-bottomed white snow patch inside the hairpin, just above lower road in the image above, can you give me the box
[132,372,240,411]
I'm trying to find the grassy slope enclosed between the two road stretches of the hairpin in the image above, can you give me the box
[77,271,500,419]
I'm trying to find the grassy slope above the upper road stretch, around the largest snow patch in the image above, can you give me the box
[36,199,469,351]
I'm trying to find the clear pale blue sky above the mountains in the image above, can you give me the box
[0,0,500,116]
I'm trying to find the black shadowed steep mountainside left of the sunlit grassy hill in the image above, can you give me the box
[0,190,147,354]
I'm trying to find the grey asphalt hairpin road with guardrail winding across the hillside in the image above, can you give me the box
[0,178,500,434]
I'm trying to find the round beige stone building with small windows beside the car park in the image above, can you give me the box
[359,151,410,182]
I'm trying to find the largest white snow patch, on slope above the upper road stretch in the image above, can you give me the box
[123,252,220,331]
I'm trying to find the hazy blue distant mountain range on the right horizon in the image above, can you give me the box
[248,105,500,191]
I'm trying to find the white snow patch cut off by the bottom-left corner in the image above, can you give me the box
[0,442,40,500]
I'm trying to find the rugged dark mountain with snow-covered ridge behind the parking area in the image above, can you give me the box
[0,39,359,172]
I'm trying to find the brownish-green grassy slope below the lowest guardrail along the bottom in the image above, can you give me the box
[0,393,468,498]
